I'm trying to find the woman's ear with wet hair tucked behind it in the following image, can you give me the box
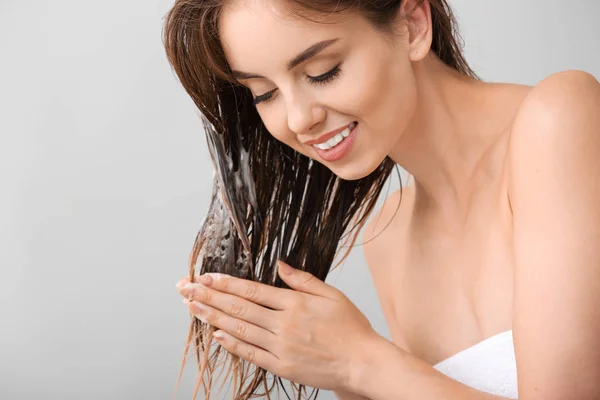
[400,0,433,61]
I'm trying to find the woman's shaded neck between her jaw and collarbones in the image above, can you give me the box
[390,57,506,223]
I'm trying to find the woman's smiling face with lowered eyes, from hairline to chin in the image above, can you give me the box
[220,1,416,180]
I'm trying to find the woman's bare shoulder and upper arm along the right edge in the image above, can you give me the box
[509,71,600,400]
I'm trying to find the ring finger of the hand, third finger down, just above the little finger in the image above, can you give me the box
[184,299,276,351]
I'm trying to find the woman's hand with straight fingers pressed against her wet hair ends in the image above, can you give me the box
[177,261,381,390]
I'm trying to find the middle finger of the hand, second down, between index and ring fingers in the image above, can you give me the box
[179,283,277,332]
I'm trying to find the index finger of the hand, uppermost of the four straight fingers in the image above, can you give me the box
[200,273,293,310]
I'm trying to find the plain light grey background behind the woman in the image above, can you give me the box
[0,0,600,400]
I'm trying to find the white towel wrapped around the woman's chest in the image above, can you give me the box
[434,330,518,399]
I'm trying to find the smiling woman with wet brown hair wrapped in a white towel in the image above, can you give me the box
[165,0,600,400]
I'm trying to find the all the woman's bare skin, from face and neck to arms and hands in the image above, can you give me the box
[178,0,600,400]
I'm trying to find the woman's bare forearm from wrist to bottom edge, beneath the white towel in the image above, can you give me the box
[348,337,506,400]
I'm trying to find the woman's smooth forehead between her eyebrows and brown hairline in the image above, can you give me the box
[219,0,357,72]
